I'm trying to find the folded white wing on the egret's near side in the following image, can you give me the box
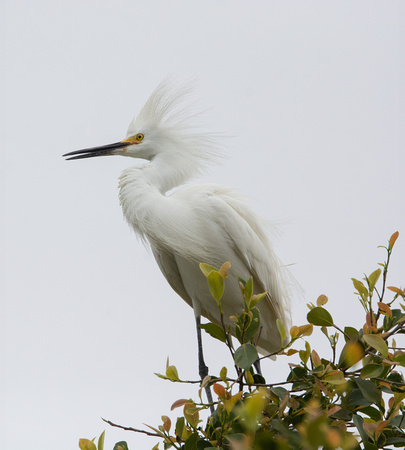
[172,185,289,324]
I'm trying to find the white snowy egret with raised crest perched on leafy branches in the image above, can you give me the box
[63,79,289,400]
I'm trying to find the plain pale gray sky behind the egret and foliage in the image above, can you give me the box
[0,0,405,450]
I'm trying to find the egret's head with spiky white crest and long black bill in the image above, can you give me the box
[63,77,218,171]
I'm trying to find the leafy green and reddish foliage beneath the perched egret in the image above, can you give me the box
[79,233,405,450]
